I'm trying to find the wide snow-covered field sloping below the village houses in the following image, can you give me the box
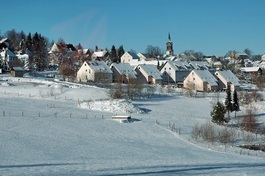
[0,75,265,176]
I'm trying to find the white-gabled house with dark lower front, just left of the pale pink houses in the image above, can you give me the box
[160,61,192,87]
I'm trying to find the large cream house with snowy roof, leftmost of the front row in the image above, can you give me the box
[77,60,112,83]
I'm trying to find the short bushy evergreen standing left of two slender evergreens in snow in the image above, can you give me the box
[211,101,226,124]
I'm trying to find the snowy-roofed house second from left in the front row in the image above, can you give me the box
[110,63,137,84]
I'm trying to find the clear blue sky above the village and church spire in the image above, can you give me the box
[0,0,265,56]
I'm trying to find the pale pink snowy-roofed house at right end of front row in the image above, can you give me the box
[215,70,240,91]
